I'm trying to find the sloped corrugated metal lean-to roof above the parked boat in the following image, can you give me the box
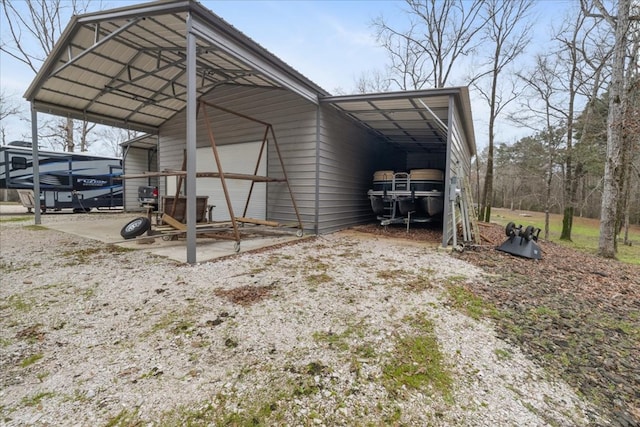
[321,87,476,155]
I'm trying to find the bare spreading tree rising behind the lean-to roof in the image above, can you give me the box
[373,0,486,90]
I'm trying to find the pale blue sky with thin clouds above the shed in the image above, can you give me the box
[0,0,577,154]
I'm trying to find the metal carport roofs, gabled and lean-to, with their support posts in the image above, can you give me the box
[25,0,475,263]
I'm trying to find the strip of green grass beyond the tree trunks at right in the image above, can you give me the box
[491,209,640,265]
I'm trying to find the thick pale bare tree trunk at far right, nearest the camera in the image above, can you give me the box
[594,0,637,258]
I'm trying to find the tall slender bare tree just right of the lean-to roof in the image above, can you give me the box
[473,0,532,226]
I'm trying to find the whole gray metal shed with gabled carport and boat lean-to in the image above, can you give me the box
[25,0,475,263]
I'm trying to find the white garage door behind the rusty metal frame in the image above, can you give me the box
[167,142,267,221]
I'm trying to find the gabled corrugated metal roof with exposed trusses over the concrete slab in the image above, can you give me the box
[25,0,328,132]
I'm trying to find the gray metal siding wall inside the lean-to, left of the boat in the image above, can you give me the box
[318,105,386,233]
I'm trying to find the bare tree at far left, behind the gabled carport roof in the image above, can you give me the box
[0,0,90,152]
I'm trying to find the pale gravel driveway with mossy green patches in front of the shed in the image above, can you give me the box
[0,213,604,426]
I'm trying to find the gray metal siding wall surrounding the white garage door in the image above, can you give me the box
[160,86,316,231]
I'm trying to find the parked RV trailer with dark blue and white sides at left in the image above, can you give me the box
[0,142,123,212]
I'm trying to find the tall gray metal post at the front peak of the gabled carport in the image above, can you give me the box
[186,13,197,264]
